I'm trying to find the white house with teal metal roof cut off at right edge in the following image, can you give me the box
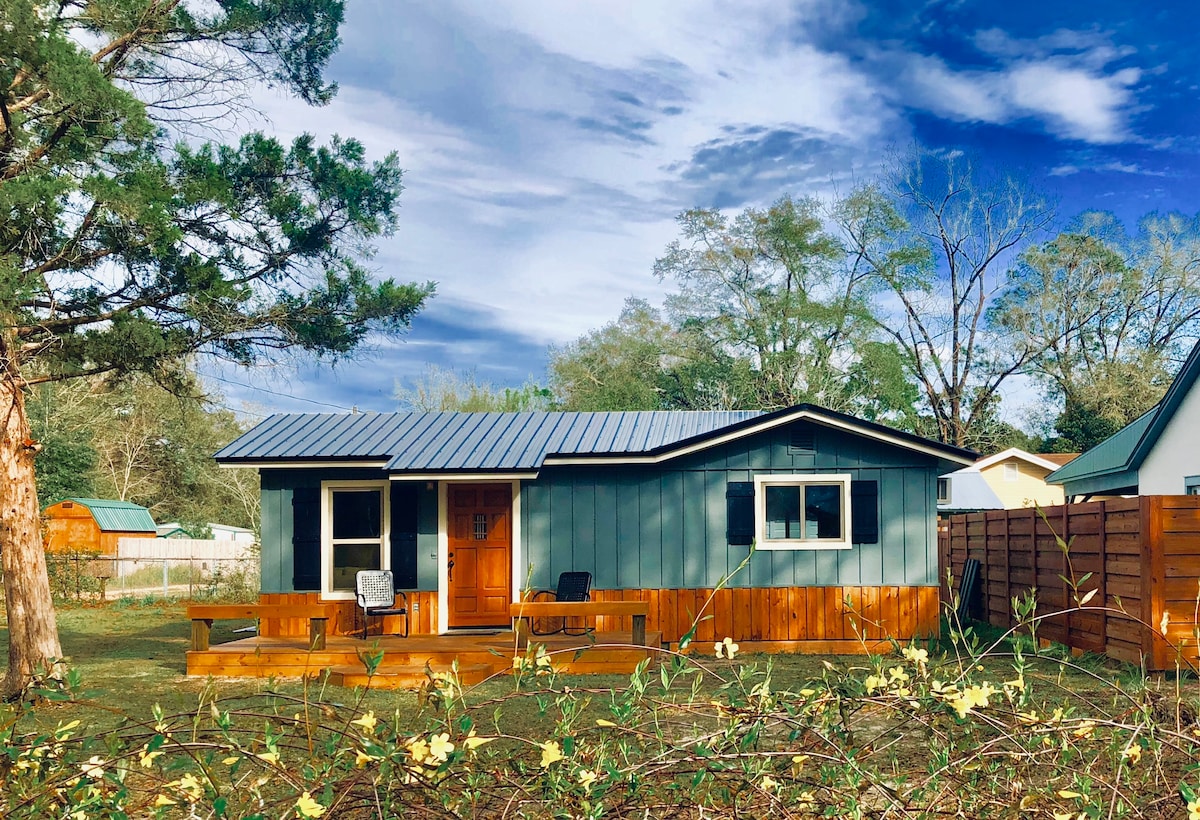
[1046,343,1200,498]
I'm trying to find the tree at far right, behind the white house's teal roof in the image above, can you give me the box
[994,211,1200,439]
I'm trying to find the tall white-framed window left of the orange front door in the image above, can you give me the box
[320,481,391,600]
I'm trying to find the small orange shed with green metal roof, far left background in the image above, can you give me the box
[42,498,156,555]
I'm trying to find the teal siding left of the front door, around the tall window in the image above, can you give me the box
[260,468,438,593]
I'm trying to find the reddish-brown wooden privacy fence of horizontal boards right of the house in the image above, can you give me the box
[938,496,1200,670]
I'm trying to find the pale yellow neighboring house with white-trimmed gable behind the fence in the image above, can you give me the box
[937,447,1076,515]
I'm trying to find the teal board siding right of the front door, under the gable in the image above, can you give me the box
[521,427,938,589]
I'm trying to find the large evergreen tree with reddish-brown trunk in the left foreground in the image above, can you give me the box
[0,0,432,692]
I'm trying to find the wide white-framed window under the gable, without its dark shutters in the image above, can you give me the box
[754,473,851,550]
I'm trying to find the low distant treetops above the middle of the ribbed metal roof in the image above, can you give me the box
[395,365,551,413]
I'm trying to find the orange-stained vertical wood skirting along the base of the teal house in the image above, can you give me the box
[260,586,941,652]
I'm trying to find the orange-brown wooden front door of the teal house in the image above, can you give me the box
[446,484,512,629]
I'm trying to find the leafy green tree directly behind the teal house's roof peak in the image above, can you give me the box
[654,197,905,417]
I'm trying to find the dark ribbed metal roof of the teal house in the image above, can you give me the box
[215,405,976,473]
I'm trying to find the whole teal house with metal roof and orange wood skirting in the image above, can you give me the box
[216,405,976,646]
